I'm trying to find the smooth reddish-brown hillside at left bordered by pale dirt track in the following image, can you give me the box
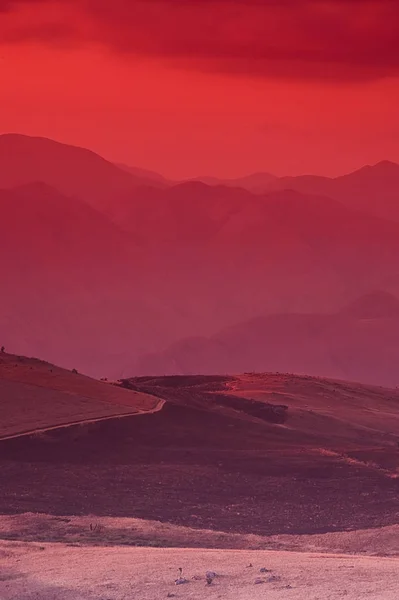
[0,352,163,440]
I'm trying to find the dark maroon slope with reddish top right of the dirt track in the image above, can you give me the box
[0,375,399,535]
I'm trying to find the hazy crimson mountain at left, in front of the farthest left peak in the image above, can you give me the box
[0,184,185,376]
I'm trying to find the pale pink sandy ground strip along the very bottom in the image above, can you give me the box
[0,542,399,600]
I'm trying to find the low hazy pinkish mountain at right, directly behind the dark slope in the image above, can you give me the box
[139,292,399,387]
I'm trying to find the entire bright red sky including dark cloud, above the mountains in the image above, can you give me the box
[0,0,399,178]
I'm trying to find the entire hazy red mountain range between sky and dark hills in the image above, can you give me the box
[0,135,399,385]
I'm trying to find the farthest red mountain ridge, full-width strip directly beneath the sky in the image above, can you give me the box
[0,134,399,221]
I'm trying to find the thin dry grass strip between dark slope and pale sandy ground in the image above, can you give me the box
[0,513,399,557]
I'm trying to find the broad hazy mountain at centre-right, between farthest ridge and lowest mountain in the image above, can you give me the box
[104,182,399,333]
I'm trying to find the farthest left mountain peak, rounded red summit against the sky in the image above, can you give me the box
[0,134,159,207]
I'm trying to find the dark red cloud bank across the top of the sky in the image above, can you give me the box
[0,0,399,80]
